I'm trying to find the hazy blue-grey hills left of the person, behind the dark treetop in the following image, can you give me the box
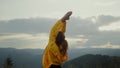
[0,48,43,68]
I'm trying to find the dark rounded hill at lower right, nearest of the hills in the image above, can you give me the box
[63,54,120,68]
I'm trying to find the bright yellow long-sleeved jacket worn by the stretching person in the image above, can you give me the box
[42,20,68,68]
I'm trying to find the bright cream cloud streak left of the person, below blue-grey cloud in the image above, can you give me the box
[0,33,48,41]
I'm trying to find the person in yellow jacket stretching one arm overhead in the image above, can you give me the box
[42,11,72,68]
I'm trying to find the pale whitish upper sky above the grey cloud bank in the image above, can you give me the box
[0,0,120,19]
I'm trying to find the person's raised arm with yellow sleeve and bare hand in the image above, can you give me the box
[49,11,72,41]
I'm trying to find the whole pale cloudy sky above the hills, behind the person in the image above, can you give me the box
[0,0,120,49]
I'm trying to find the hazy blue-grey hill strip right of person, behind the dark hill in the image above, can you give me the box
[69,48,120,60]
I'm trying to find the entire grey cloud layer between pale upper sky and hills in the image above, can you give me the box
[0,15,120,48]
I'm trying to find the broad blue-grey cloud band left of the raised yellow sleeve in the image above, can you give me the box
[0,18,56,33]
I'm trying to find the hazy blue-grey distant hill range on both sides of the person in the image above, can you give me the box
[0,48,120,68]
